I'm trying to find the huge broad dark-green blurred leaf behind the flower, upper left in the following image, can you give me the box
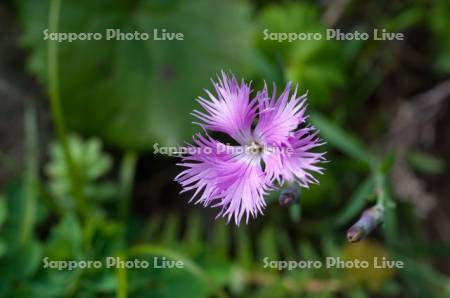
[17,0,252,150]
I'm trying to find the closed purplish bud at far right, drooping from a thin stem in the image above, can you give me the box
[347,205,384,242]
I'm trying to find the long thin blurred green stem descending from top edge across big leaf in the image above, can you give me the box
[47,0,88,218]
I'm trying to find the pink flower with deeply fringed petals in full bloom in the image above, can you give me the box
[175,72,324,225]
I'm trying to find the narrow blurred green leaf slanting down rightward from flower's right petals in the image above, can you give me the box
[311,113,374,165]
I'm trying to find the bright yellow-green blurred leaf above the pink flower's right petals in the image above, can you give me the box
[258,3,346,106]
